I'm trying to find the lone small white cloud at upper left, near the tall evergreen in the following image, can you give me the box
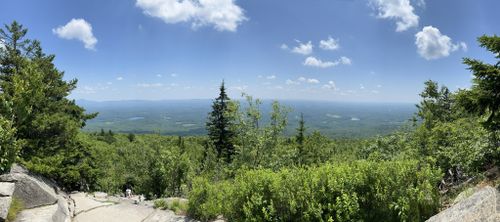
[52,19,97,50]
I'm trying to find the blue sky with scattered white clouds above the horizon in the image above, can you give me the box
[0,0,500,102]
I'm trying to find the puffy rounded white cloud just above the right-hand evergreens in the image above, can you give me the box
[415,26,467,60]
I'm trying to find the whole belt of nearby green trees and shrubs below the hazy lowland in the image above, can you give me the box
[0,22,500,221]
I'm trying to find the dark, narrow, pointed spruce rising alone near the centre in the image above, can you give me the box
[206,81,235,163]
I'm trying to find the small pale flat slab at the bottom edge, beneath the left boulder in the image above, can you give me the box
[15,204,59,222]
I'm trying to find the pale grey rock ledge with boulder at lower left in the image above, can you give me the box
[0,165,199,222]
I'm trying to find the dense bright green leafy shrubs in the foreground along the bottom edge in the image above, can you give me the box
[188,161,441,221]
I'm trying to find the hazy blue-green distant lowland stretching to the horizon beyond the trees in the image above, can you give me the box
[77,99,416,138]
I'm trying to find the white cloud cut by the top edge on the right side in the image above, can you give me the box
[371,0,419,32]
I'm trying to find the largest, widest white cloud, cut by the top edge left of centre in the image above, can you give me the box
[135,0,247,32]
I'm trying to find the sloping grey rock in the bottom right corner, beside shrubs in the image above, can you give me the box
[427,186,500,222]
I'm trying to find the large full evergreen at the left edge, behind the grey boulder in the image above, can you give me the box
[0,21,96,189]
